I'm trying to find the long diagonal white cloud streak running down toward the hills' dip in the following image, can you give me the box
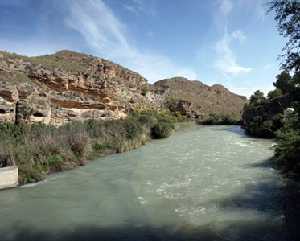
[65,0,197,82]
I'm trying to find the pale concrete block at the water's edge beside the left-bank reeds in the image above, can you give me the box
[0,166,18,190]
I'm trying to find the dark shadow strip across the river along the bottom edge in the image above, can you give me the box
[1,222,284,241]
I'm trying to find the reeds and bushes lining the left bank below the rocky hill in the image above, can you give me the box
[0,112,175,184]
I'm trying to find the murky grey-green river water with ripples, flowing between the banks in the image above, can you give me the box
[0,126,292,241]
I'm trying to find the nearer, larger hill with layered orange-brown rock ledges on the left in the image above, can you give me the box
[0,51,152,125]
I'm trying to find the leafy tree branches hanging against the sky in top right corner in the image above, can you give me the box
[269,0,300,72]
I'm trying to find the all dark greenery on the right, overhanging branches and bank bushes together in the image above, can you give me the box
[243,0,300,175]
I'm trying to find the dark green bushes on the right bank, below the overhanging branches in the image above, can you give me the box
[243,72,300,175]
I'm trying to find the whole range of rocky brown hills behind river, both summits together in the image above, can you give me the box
[0,51,246,126]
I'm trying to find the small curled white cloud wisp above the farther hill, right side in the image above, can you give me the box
[215,30,252,77]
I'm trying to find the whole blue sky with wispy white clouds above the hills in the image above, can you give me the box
[0,0,284,96]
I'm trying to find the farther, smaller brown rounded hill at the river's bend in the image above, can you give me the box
[152,77,247,120]
